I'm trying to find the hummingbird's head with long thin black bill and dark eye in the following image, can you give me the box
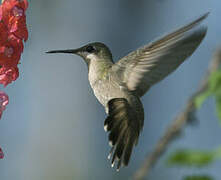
[46,42,112,65]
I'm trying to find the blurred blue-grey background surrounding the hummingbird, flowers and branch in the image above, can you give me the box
[0,0,221,180]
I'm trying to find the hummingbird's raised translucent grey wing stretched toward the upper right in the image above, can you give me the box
[113,13,209,96]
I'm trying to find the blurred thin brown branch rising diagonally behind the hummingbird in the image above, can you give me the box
[133,49,221,180]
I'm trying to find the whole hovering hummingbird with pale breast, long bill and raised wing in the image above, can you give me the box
[47,13,209,170]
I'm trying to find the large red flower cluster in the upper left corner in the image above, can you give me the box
[0,0,28,86]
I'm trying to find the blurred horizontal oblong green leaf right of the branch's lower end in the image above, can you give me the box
[167,149,215,167]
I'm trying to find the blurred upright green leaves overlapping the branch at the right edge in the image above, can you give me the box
[195,70,221,121]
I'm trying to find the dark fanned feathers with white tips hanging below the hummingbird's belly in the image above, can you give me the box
[104,98,141,170]
